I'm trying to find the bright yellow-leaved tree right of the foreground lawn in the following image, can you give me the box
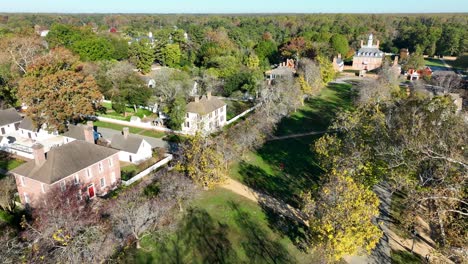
[304,170,382,262]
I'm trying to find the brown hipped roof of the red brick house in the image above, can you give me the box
[12,140,118,184]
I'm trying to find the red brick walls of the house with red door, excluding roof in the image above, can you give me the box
[15,153,121,205]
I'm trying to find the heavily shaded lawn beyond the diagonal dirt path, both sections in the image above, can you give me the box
[230,85,351,206]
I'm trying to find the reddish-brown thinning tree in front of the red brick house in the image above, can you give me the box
[22,185,106,263]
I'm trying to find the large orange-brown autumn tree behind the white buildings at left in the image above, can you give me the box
[18,48,102,130]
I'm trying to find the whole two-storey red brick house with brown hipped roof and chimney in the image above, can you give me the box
[11,140,120,206]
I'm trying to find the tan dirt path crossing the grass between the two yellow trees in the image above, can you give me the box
[221,178,309,226]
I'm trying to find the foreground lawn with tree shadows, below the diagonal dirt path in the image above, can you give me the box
[124,189,314,263]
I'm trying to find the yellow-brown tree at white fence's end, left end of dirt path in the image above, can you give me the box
[180,133,226,189]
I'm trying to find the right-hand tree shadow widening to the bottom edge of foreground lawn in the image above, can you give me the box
[228,201,294,263]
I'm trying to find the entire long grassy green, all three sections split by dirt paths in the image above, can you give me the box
[125,85,349,263]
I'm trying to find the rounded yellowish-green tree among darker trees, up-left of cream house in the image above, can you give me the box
[128,41,155,73]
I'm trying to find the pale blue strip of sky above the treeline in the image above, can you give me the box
[0,0,468,13]
